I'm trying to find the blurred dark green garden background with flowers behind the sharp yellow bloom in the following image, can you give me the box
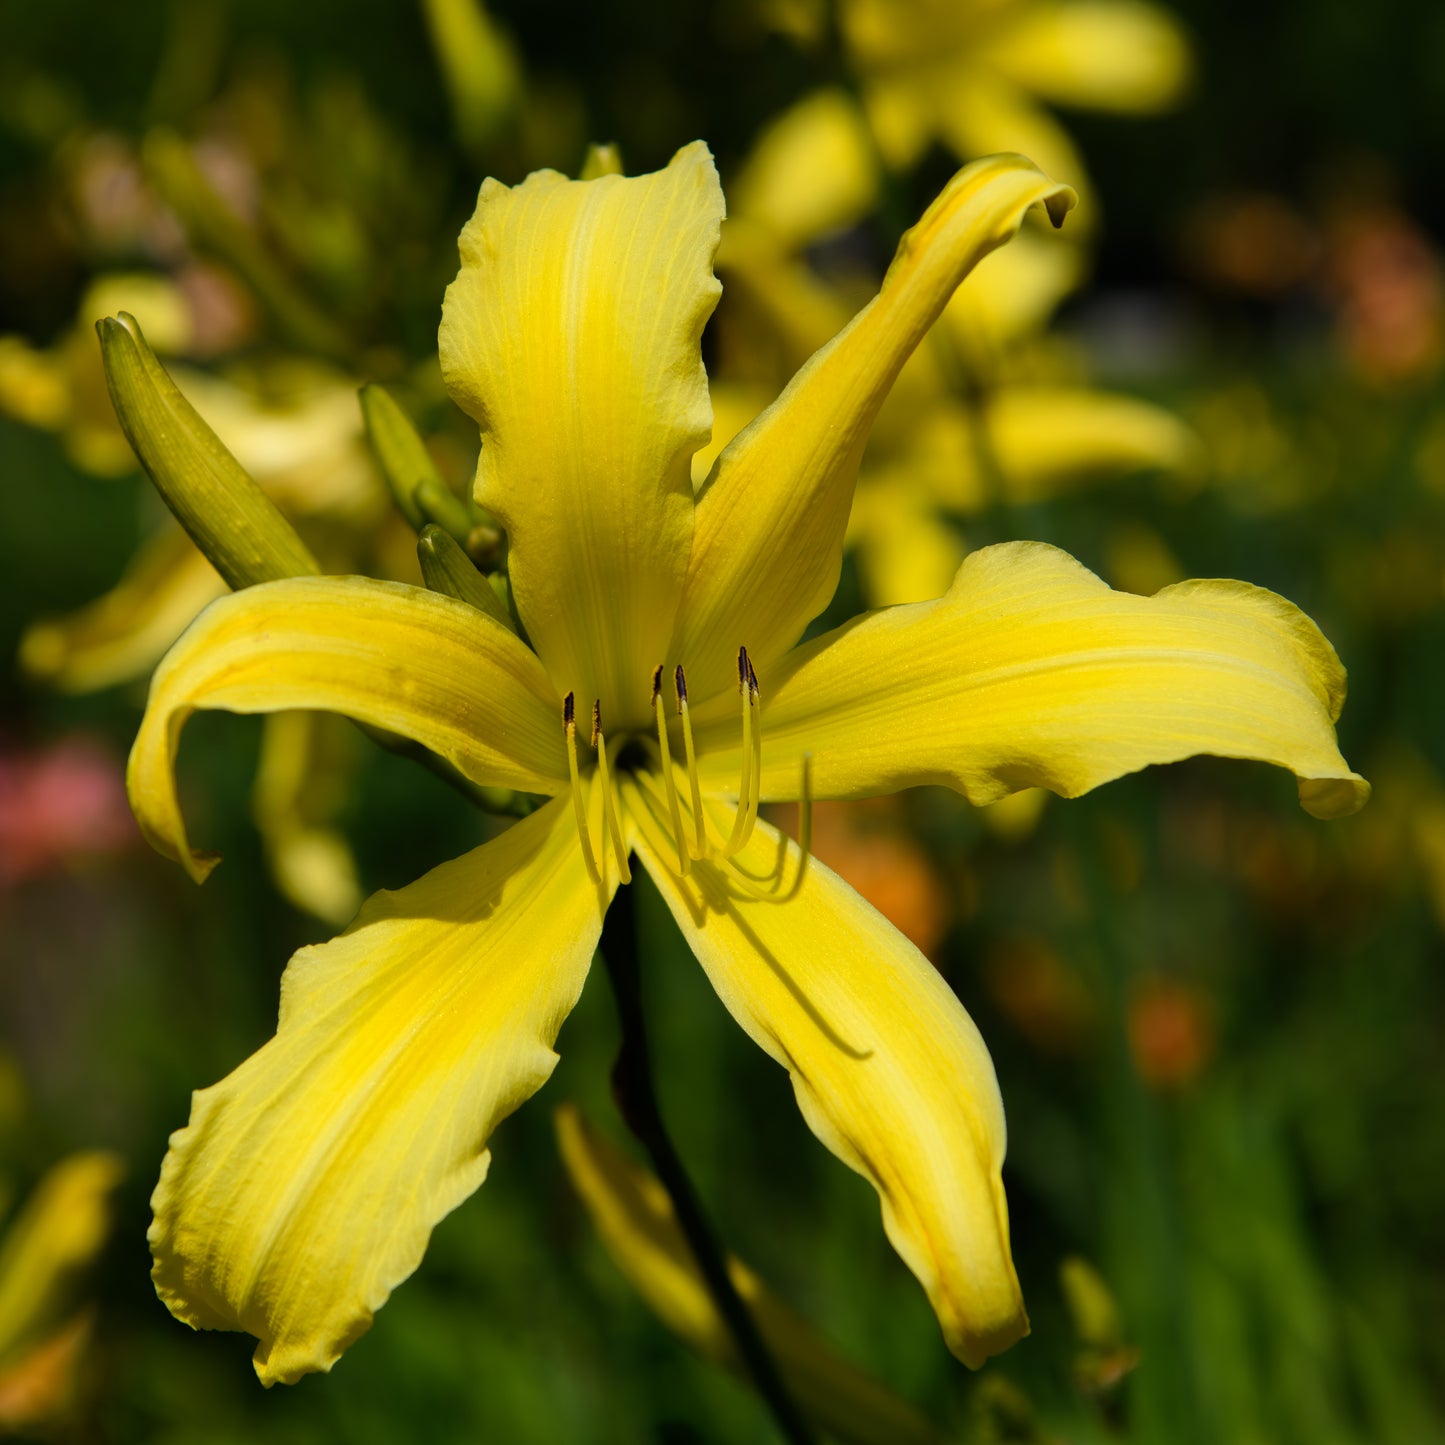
[0,0,1445,1445]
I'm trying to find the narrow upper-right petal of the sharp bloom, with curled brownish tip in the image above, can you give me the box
[670,156,1074,696]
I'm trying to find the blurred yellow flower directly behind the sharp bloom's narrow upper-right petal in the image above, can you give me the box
[716,91,1199,604]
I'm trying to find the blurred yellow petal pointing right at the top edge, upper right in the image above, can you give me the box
[978,0,1189,114]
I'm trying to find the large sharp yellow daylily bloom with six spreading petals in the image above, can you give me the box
[130,145,1367,1383]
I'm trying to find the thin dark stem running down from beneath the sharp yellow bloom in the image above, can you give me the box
[601,889,814,1445]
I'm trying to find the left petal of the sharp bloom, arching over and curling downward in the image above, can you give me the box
[126,577,568,881]
